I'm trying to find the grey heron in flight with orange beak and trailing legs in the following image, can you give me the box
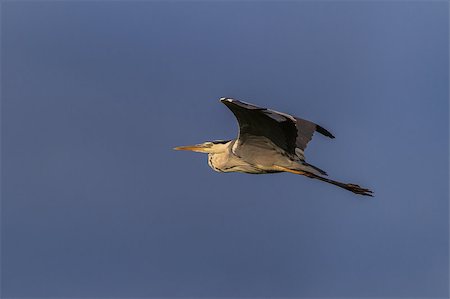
[174,98,373,196]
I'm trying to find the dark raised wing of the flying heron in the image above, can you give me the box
[220,98,334,154]
